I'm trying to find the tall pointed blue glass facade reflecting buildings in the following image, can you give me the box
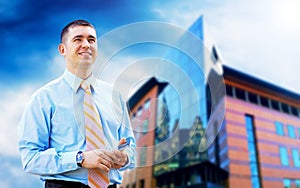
[154,16,207,175]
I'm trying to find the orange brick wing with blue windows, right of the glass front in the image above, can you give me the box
[213,66,300,188]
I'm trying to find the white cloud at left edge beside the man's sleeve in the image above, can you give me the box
[0,86,35,156]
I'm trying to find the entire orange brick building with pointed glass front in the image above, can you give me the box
[119,17,300,188]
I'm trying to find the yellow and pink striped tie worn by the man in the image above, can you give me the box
[81,81,109,188]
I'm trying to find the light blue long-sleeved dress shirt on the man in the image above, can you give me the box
[18,70,136,184]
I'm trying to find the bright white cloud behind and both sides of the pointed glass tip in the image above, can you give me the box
[153,0,300,93]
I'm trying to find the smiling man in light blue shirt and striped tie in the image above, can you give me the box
[18,20,136,188]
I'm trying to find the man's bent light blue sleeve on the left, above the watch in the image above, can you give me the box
[18,95,79,175]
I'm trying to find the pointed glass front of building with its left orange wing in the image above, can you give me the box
[122,16,228,187]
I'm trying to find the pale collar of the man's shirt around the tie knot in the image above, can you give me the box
[63,69,96,93]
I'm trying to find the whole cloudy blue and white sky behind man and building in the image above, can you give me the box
[0,0,300,187]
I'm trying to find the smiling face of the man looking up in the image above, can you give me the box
[59,26,98,73]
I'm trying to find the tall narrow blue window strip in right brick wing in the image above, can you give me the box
[245,115,261,188]
